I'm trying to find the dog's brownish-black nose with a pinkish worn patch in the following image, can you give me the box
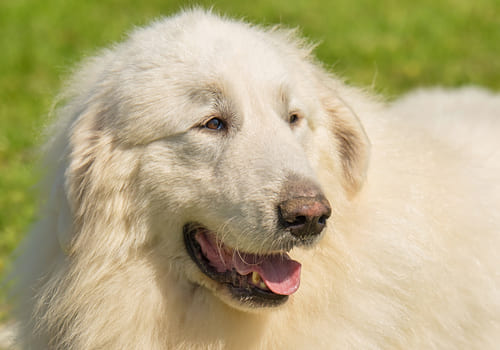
[278,178,332,239]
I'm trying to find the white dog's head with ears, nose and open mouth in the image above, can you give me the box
[62,13,367,308]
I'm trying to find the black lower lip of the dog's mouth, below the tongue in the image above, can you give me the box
[183,223,288,307]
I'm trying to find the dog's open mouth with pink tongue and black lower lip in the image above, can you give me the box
[183,223,301,307]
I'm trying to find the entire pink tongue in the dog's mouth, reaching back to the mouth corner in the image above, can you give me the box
[196,233,301,295]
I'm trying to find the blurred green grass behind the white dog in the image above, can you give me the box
[0,0,500,317]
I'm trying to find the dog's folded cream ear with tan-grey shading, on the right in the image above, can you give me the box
[320,74,370,196]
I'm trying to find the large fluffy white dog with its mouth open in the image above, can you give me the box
[8,10,500,350]
